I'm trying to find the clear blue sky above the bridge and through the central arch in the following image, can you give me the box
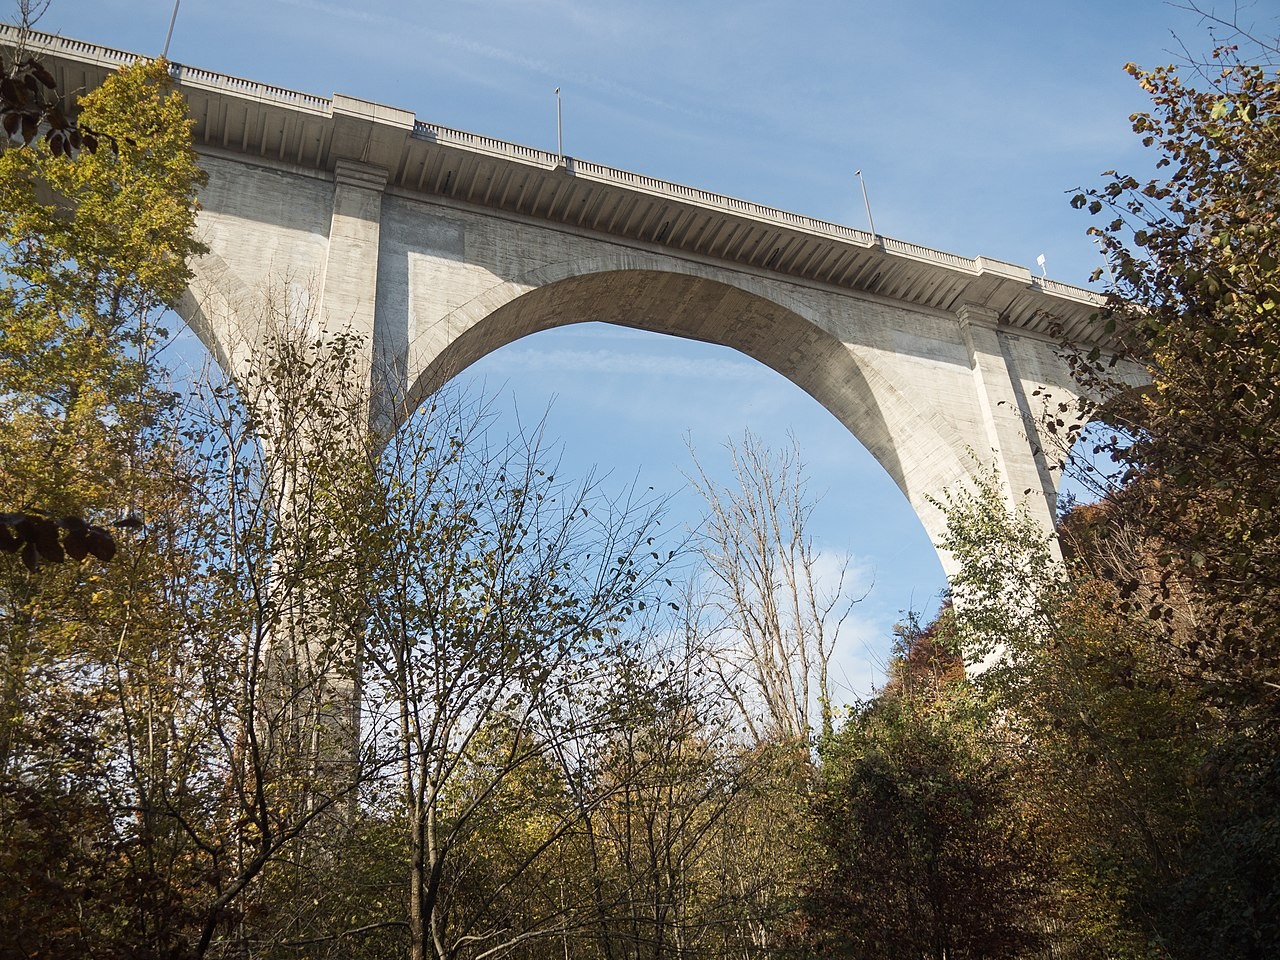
[38,0,1244,695]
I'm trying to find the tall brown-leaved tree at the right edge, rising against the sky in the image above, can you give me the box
[1073,32,1280,714]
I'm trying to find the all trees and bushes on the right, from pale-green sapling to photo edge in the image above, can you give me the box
[948,30,1280,957]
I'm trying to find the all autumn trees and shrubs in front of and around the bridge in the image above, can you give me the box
[0,16,1280,960]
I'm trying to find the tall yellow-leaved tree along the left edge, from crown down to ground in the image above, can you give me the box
[0,58,212,955]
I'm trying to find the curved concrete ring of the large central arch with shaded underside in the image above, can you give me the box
[396,256,975,555]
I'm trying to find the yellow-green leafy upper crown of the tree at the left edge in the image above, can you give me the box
[0,61,204,568]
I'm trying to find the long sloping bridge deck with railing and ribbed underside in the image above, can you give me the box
[0,24,1101,340]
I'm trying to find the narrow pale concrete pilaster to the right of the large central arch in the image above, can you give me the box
[956,303,1057,552]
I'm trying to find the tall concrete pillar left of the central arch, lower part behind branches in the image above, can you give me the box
[261,160,387,813]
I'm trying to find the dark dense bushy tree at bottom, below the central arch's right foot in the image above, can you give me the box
[799,616,1048,960]
